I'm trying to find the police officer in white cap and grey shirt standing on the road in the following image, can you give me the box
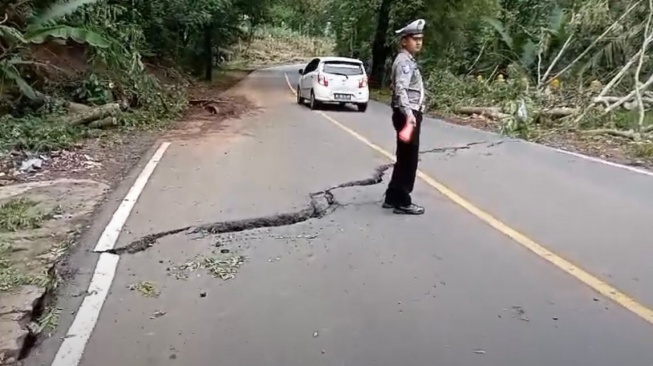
[383,19,426,215]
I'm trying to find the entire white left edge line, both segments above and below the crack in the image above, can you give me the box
[52,142,170,366]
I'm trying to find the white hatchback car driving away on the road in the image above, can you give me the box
[297,57,370,112]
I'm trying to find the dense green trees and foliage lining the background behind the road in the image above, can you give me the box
[0,0,653,145]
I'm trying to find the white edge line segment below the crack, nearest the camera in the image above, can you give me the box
[52,253,120,366]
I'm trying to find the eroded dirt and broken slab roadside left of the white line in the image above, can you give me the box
[0,71,254,365]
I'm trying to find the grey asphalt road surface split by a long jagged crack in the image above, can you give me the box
[26,66,653,366]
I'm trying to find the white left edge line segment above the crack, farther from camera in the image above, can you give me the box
[93,142,170,252]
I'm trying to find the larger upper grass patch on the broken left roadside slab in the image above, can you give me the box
[0,197,50,232]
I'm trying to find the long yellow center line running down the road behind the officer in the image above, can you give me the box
[284,74,653,324]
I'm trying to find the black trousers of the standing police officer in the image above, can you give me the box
[385,108,422,206]
